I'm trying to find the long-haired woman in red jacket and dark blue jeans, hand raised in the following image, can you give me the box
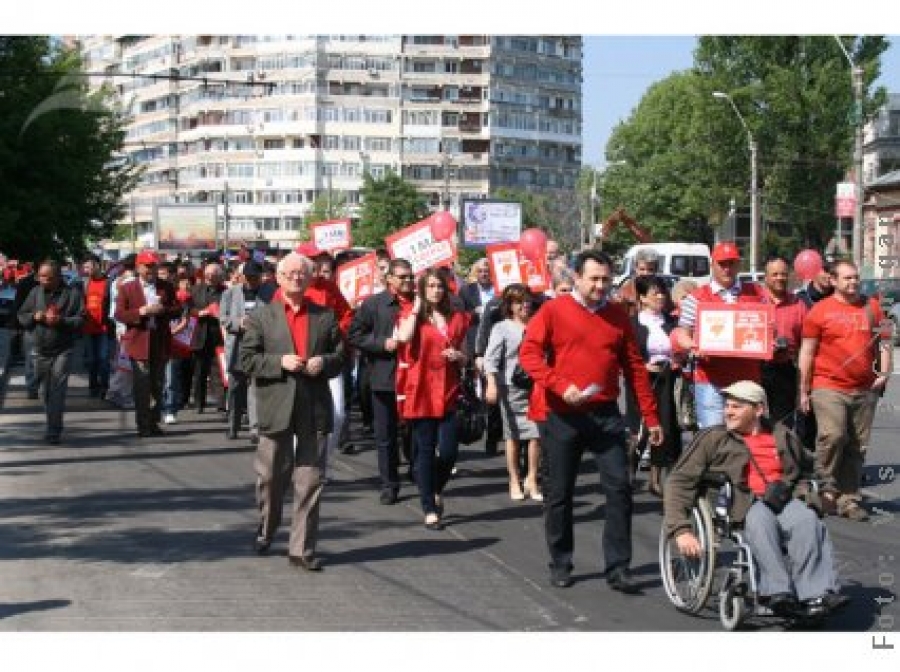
[397,269,469,530]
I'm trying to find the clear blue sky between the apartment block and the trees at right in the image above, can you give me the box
[582,35,900,167]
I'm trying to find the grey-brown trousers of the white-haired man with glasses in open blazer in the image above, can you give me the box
[254,431,328,558]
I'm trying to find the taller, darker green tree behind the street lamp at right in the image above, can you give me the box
[695,36,889,254]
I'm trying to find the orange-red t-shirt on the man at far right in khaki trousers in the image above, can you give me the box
[803,296,881,392]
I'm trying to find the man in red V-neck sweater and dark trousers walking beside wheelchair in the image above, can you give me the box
[519,250,663,593]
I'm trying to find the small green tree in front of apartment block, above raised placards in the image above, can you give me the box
[353,172,429,247]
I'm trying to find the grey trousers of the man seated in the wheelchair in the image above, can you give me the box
[744,499,839,600]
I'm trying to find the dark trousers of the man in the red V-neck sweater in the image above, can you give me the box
[539,402,633,572]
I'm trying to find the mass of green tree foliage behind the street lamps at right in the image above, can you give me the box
[601,36,888,262]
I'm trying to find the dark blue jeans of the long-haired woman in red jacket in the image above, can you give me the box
[410,412,459,515]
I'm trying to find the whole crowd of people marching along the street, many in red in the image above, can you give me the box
[3,241,893,610]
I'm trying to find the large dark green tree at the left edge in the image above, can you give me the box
[0,36,137,259]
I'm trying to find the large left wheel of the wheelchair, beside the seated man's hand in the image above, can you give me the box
[659,497,716,614]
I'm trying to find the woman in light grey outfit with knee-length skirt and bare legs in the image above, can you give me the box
[484,284,544,502]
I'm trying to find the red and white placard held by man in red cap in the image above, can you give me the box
[694,302,775,359]
